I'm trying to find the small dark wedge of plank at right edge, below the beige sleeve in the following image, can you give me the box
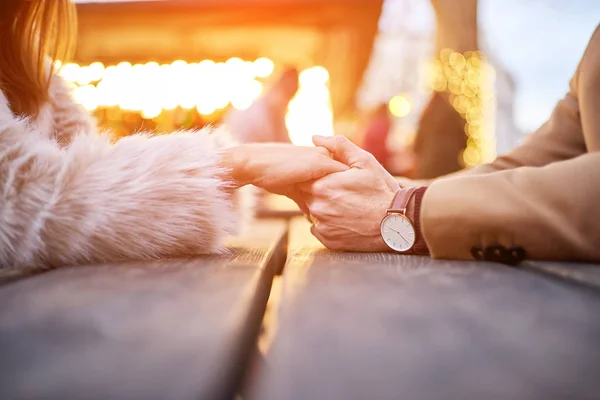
[523,261,600,290]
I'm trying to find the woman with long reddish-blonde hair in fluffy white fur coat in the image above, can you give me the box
[0,0,347,267]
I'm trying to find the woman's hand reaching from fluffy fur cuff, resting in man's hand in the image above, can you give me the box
[221,143,349,194]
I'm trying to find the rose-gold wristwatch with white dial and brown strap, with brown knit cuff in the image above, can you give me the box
[380,187,429,254]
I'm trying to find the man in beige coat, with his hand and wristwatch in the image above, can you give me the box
[301,27,600,264]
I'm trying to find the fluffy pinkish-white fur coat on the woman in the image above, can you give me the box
[0,77,250,268]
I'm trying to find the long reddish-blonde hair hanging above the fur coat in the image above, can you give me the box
[0,0,77,115]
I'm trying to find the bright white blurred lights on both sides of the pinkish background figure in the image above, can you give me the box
[57,57,333,145]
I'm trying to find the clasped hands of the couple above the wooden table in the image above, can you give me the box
[221,136,400,251]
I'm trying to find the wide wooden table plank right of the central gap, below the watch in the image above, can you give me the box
[252,221,600,400]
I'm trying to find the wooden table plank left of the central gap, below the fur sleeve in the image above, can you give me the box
[0,222,285,400]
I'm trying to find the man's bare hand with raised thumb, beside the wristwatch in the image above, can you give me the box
[299,136,400,251]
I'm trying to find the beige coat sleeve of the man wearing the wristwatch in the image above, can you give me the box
[421,25,600,260]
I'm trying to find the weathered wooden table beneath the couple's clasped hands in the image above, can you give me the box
[0,219,600,400]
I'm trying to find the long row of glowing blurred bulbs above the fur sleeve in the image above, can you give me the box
[57,57,274,119]
